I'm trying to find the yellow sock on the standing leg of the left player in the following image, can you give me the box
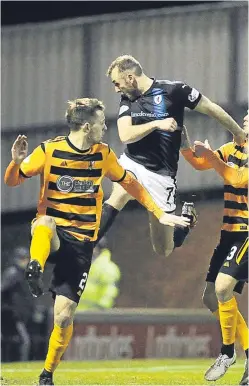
[44,324,73,373]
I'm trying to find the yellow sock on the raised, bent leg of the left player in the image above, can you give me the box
[30,225,53,270]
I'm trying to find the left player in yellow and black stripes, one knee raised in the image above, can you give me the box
[5,98,189,385]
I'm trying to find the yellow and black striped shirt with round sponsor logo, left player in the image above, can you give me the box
[17,137,125,241]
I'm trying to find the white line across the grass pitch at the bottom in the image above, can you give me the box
[2,364,244,373]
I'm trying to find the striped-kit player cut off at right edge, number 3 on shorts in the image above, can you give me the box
[181,116,249,385]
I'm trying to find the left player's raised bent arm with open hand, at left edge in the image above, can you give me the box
[4,135,45,186]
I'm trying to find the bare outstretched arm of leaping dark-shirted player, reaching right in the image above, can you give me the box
[195,95,246,145]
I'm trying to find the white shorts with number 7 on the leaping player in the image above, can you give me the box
[119,153,177,213]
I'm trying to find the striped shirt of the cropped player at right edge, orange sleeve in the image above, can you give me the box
[181,142,249,232]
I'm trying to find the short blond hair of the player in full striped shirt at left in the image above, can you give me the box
[65,98,105,130]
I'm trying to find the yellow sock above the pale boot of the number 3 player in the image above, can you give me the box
[219,296,238,345]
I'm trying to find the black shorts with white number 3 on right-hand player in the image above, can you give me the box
[206,231,248,294]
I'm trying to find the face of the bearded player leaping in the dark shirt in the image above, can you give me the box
[111,67,140,99]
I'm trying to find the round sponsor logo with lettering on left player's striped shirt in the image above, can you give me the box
[56,176,94,193]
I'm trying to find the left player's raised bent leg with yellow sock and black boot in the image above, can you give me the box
[25,216,60,297]
